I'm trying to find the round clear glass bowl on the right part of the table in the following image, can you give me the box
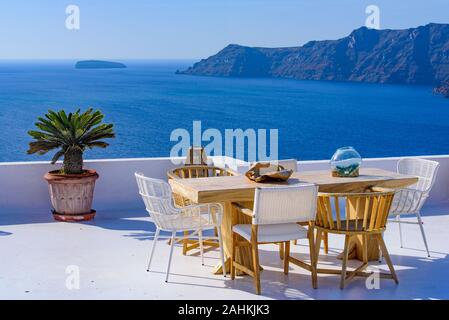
[331,147,362,177]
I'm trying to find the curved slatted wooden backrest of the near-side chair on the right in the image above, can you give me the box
[315,188,395,233]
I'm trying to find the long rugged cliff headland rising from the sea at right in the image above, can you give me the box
[178,23,449,96]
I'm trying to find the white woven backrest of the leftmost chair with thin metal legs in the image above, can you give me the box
[135,173,178,227]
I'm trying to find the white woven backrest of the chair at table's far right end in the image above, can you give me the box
[398,158,440,193]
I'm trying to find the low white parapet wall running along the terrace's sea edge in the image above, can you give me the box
[0,155,449,224]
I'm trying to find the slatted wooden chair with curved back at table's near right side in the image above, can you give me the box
[314,188,399,289]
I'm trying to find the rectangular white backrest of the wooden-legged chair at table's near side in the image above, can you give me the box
[253,184,318,225]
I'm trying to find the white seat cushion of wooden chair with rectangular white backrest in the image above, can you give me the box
[232,223,307,242]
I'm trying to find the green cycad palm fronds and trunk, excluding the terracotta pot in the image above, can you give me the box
[28,109,115,174]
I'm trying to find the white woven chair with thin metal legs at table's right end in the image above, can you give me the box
[390,158,440,257]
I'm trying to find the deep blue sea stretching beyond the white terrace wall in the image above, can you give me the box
[0,61,449,162]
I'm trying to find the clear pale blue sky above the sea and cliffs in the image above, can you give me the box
[0,0,449,60]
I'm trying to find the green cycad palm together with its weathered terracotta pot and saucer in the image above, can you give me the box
[28,109,115,222]
